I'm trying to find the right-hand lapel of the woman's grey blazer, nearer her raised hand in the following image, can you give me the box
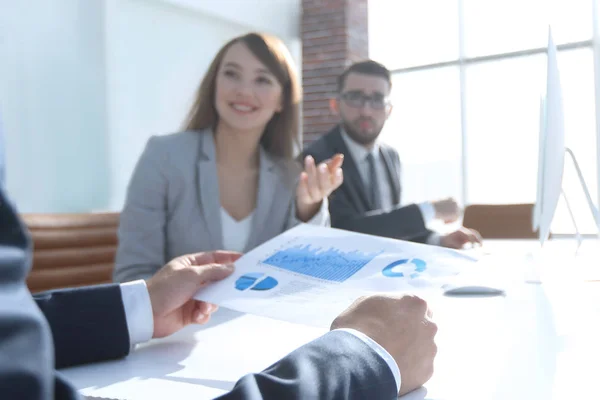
[245,146,279,250]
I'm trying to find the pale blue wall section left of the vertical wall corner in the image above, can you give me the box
[0,0,109,212]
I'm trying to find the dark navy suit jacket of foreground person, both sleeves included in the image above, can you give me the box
[0,183,397,400]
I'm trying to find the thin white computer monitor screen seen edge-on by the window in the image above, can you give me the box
[532,29,565,244]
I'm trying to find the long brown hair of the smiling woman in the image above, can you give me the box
[184,33,302,159]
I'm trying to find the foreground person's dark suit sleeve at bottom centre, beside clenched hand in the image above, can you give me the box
[219,332,398,400]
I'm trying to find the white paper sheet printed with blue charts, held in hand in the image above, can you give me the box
[196,225,477,328]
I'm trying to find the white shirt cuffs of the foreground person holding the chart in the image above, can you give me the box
[121,279,402,391]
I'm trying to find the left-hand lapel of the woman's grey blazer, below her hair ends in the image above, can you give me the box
[197,130,223,249]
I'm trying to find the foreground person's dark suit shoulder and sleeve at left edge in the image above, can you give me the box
[0,188,129,400]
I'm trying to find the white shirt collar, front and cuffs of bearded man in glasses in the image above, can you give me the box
[340,128,440,245]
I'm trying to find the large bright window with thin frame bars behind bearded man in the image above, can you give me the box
[369,0,600,233]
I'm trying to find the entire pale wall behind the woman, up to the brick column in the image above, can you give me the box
[0,0,301,212]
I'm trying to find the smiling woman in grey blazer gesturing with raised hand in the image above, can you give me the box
[114,33,342,282]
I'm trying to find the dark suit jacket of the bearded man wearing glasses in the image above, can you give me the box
[303,126,432,242]
